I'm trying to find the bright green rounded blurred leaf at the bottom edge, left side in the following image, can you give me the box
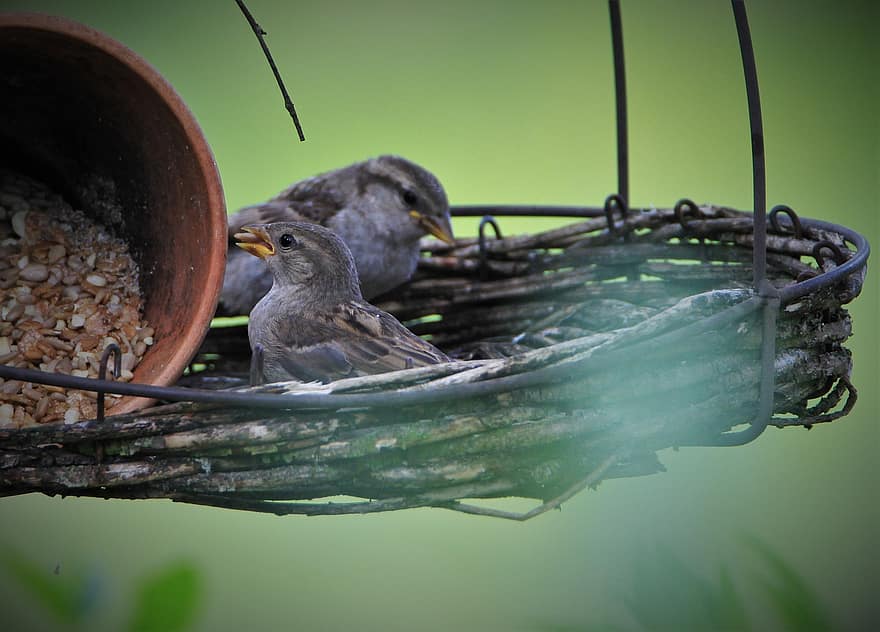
[128,562,202,632]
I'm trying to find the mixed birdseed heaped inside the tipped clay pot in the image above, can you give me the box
[0,169,155,427]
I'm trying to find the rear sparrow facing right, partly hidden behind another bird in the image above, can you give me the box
[219,156,453,316]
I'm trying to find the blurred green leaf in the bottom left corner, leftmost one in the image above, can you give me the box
[0,550,95,625]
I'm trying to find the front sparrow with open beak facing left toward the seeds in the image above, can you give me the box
[235,222,449,384]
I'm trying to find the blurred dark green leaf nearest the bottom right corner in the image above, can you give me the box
[746,536,833,632]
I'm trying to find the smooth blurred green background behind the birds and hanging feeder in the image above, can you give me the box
[0,0,880,630]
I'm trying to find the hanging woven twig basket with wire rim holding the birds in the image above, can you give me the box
[0,203,867,519]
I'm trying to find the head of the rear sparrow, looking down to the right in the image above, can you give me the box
[357,156,453,244]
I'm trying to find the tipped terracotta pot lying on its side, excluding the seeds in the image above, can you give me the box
[0,14,226,414]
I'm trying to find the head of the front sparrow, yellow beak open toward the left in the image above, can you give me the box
[235,222,361,302]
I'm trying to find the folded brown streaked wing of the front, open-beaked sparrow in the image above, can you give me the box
[278,301,449,382]
